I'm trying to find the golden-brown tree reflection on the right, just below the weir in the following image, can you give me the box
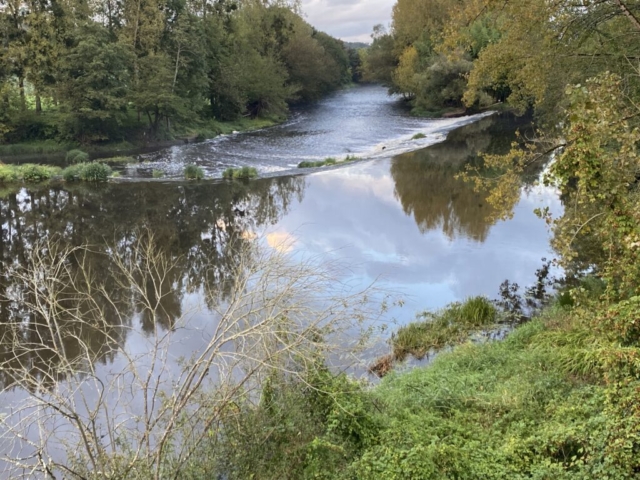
[391,112,517,242]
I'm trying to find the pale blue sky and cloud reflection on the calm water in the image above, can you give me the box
[262,160,561,321]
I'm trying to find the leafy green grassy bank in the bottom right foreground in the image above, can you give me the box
[190,296,640,480]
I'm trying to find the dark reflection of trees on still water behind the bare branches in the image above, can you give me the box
[0,177,305,387]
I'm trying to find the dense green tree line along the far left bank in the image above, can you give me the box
[0,0,358,144]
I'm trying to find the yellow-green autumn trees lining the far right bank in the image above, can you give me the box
[364,0,640,118]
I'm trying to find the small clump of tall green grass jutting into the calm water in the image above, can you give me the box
[391,297,498,361]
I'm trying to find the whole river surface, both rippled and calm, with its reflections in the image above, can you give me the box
[0,86,561,474]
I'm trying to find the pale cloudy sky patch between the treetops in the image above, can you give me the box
[302,0,396,43]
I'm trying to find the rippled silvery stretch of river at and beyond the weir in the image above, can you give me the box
[122,86,500,179]
